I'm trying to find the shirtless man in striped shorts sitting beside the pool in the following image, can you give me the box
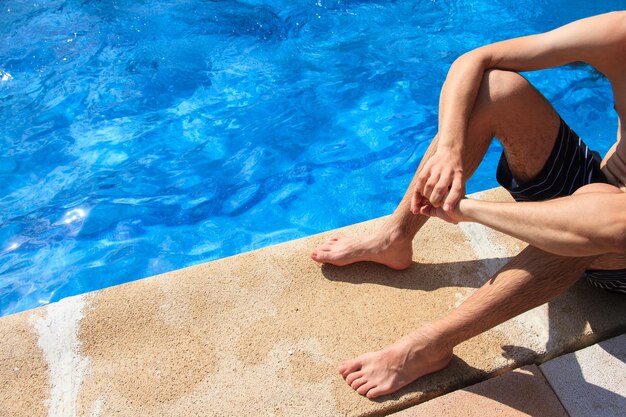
[311,12,626,398]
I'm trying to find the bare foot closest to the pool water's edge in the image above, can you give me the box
[311,231,413,269]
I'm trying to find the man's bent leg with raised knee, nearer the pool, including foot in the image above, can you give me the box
[311,70,559,269]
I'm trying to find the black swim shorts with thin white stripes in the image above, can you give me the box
[496,119,626,293]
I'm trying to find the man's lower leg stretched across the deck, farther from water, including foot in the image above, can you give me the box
[339,246,594,398]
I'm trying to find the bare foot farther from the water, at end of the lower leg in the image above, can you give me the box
[339,330,452,398]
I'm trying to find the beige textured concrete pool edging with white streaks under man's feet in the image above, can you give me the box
[0,189,626,417]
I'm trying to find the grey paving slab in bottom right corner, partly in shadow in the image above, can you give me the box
[541,332,626,417]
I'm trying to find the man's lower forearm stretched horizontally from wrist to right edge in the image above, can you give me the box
[458,193,626,257]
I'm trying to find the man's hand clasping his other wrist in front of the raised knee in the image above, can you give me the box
[411,149,465,214]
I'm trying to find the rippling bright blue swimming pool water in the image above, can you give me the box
[0,0,623,314]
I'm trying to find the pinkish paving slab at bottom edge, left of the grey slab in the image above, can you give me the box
[393,365,568,417]
